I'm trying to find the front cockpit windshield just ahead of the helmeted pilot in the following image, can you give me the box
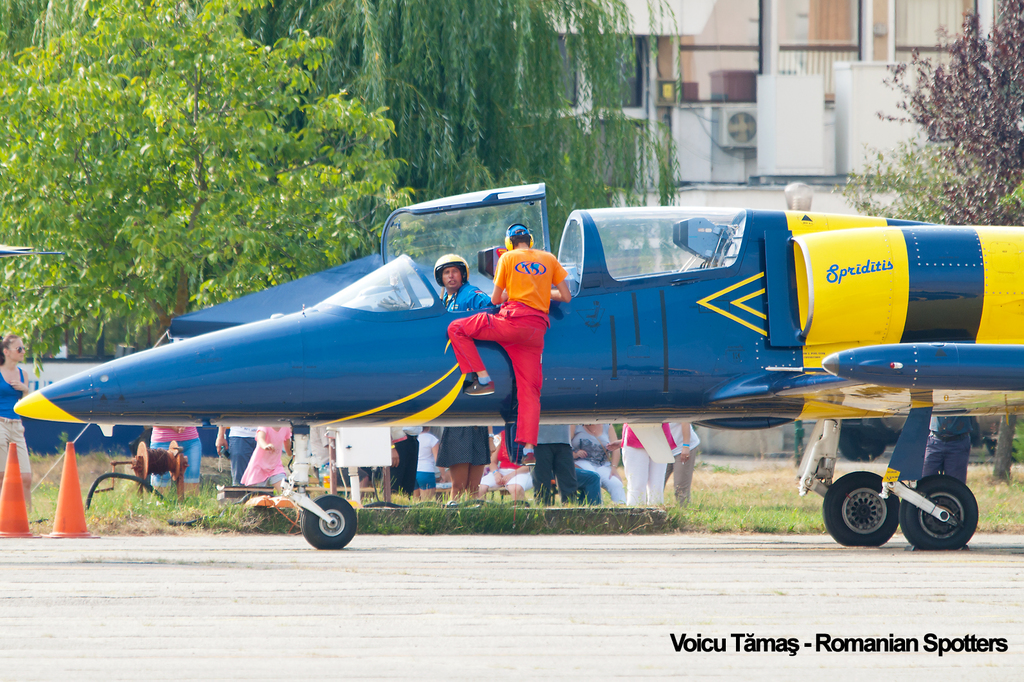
[315,256,437,312]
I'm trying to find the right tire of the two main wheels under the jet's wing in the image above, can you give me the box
[899,474,978,550]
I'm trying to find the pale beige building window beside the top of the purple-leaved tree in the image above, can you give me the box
[896,0,977,61]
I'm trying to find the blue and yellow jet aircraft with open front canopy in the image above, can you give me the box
[15,184,1024,549]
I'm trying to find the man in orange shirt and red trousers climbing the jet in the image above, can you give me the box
[449,223,569,456]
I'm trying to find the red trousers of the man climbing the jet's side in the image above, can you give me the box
[449,301,549,444]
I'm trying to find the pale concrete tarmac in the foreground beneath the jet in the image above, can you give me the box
[0,535,1024,681]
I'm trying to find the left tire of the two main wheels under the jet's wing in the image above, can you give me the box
[821,471,899,547]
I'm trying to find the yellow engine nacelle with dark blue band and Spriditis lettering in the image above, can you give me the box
[793,225,1024,358]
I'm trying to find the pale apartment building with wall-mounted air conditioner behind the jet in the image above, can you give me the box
[624,0,997,212]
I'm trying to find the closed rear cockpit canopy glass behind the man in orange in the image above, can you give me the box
[587,206,746,280]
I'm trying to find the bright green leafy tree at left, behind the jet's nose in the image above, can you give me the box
[0,0,400,349]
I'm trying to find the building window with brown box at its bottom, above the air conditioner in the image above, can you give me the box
[679,0,761,101]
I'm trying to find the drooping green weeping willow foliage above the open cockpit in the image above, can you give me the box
[236,0,676,227]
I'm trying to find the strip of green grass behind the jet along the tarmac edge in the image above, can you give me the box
[19,456,1024,536]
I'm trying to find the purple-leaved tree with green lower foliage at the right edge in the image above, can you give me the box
[847,0,1024,224]
